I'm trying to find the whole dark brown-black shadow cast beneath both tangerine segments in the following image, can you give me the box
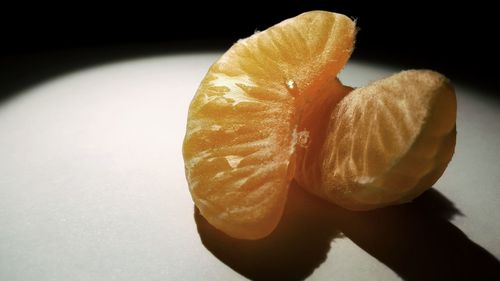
[194,183,500,280]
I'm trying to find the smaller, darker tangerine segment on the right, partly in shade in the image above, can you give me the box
[298,70,457,210]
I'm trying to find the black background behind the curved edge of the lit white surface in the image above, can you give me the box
[0,0,499,100]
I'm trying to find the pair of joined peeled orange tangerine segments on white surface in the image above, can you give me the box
[183,11,456,239]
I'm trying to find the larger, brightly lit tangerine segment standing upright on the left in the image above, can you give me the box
[183,11,355,239]
